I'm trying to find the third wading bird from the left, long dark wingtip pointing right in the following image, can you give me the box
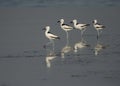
[70,19,90,37]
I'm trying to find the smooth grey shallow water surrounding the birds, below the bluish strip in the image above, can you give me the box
[0,7,120,86]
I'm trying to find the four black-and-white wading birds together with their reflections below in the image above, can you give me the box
[43,19,105,67]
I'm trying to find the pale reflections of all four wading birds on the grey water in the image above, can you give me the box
[45,32,108,68]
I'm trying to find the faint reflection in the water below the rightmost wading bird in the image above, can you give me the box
[94,40,109,56]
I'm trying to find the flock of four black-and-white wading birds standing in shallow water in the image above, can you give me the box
[43,19,105,46]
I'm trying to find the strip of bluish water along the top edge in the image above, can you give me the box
[0,0,120,7]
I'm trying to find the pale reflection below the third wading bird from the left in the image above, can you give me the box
[74,37,90,53]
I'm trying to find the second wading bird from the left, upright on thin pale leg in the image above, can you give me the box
[58,19,73,43]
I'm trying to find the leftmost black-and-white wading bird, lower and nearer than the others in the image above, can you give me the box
[43,26,60,51]
